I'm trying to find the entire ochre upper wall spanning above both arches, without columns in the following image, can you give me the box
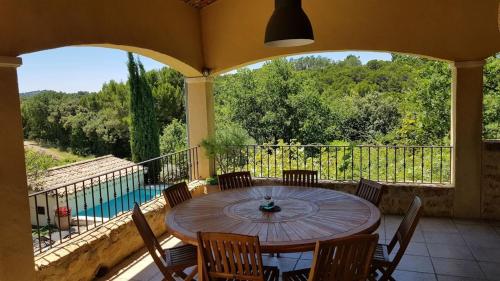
[0,0,500,77]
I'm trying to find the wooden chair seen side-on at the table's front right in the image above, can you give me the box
[370,196,423,280]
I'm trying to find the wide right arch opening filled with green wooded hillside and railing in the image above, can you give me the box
[214,50,460,183]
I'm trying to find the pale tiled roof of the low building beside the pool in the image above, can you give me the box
[32,155,142,193]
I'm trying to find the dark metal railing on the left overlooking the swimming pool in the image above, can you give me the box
[29,147,199,254]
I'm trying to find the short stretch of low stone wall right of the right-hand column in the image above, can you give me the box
[481,141,500,219]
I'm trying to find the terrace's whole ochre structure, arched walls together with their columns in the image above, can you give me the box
[0,0,500,280]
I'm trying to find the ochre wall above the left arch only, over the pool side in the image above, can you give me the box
[0,0,204,76]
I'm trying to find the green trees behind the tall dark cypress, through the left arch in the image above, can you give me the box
[21,67,185,158]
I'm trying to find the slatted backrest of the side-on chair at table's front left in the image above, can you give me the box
[132,203,168,274]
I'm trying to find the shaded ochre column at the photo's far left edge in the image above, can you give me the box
[0,57,35,281]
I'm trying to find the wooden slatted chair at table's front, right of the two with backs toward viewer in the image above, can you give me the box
[283,234,378,281]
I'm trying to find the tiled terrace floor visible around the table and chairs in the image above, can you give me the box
[101,216,500,281]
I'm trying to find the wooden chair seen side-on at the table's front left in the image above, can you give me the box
[132,203,197,281]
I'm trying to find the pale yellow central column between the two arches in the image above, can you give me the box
[185,77,215,179]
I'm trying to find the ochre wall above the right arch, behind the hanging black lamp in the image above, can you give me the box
[201,0,500,72]
